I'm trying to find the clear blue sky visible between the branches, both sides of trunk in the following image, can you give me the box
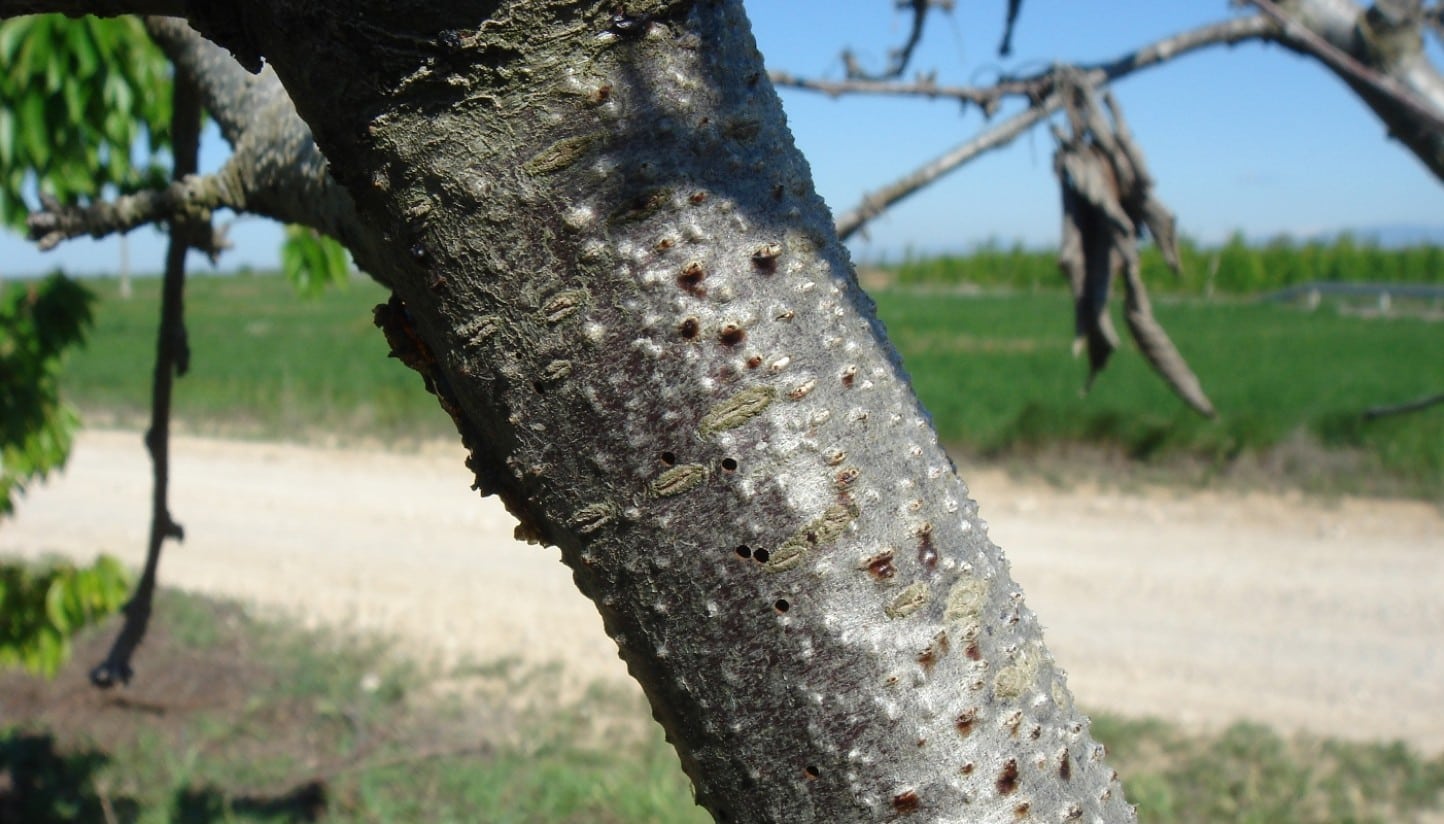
[0,0,1444,276]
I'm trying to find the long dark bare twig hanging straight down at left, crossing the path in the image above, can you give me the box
[90,71,211,688]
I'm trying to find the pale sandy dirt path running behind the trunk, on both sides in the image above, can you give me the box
[0,431,1444,752]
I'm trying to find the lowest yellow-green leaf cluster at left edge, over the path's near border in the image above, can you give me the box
[0,556,130,677]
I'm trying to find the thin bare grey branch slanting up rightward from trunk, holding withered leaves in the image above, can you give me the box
[836,16,1275,240]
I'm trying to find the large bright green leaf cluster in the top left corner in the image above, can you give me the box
[0,14,170,228]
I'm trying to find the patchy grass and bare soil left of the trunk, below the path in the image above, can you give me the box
[0,592,706,824]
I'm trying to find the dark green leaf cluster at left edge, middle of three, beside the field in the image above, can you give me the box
[0,274,95,515]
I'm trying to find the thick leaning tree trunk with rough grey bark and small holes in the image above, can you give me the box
[161,1,1132,821]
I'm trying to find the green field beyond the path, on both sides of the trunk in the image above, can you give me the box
[64,277,1444,498]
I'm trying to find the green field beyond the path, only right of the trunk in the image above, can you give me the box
[878,292,1444,496]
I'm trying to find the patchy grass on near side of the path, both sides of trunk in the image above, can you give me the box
[0,592,1444,824]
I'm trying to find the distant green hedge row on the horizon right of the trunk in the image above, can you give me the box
[881,235,1444,294]
